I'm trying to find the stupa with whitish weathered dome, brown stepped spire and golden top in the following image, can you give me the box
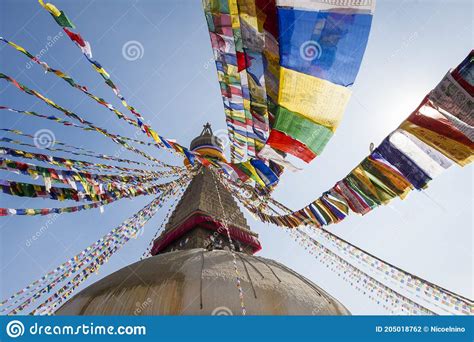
[56,124,350,315]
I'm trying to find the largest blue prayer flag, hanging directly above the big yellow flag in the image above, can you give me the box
[278,8,372,86]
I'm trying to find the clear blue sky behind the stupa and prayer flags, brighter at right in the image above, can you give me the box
[0,0,474,314]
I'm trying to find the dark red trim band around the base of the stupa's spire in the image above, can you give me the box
[151,214,262,255]
